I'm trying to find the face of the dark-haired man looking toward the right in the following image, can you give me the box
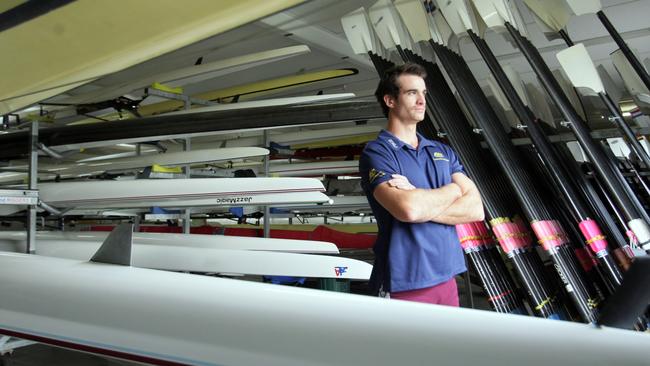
[384,74,427,123]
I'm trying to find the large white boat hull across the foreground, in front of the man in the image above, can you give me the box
[0,253,650,366]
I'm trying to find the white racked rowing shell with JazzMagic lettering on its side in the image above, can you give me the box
[39,178,329,208]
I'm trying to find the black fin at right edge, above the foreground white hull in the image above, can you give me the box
[598,256,650,329]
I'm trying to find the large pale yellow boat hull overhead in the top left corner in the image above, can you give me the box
[0,0,301,114]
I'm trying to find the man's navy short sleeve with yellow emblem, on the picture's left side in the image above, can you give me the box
[359,143,400,193]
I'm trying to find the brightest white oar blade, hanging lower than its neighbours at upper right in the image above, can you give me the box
[556,43,605,93]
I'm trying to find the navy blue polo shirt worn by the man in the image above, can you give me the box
[359,130,466,293]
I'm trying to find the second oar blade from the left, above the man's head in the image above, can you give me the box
[368,0,412,49]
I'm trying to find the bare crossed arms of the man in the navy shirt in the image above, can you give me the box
[374,173,484,225]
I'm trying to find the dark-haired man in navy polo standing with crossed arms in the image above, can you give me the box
[359,63,484,306]
